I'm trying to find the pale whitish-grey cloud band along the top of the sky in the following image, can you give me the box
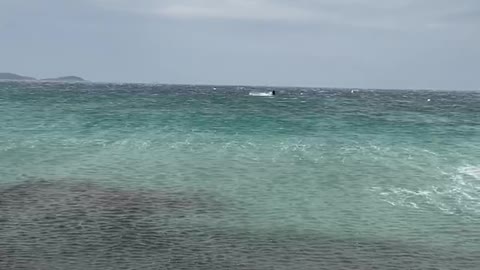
[91,0,480,29]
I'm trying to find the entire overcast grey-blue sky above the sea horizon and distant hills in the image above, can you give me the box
[0,0,480,89]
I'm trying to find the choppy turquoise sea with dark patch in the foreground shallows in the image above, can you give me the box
[0,82,480,269]
